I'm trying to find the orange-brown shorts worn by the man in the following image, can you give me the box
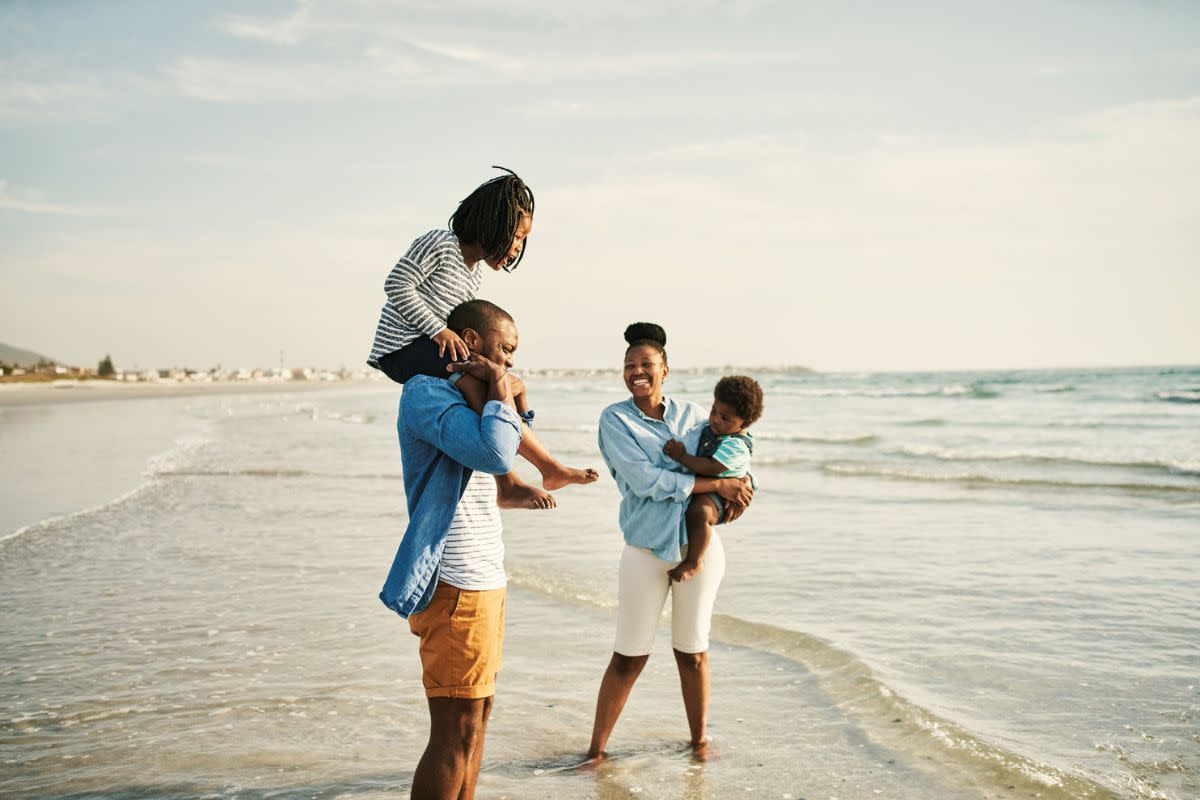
[408,582,505,699]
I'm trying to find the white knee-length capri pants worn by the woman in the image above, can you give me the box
[612,530,725,656]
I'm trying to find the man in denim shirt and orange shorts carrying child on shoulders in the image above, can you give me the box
[379,300,540,800]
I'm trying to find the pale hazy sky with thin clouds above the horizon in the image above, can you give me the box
[0,0,1200,371]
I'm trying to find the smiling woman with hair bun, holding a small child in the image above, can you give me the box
[588,323,754,758]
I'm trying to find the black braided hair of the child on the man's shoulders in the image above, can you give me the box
[450,166,533,271]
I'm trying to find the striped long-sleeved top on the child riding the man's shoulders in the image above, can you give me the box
[367,230,484,369]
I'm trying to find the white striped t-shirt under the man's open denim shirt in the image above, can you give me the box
[438,470,508,591]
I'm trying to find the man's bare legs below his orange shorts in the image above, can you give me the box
[412,697,491,800]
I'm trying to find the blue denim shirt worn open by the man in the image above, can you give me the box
[379,375,521,618]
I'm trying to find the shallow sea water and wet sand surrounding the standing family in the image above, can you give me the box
[0,367,1200,800]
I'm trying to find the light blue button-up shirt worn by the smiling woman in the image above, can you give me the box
[600,397,708,561]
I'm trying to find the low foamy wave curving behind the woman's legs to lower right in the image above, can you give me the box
[509,567,1115,800]
